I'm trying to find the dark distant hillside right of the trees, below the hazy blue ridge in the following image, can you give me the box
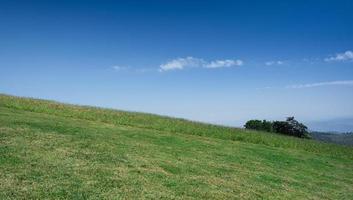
[310,132,353,146]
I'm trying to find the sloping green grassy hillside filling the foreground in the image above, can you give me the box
[0,95,353,199]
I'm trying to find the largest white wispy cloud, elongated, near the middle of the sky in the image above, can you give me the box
[159,56,244,71]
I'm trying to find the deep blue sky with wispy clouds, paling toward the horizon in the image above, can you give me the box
[0,0,353,130]
